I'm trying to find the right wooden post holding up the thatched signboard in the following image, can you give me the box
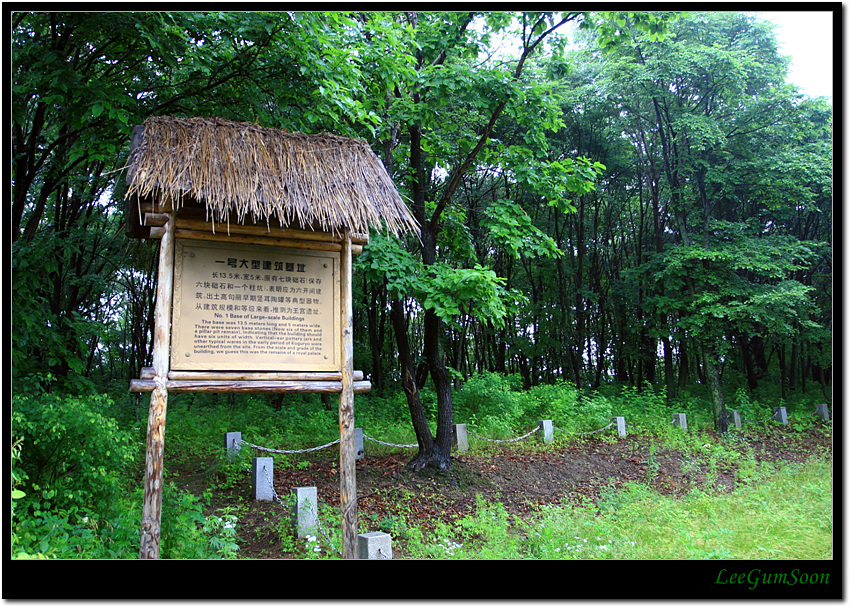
[339,229,357,559]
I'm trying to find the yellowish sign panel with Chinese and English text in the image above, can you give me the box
[171,239,340,371]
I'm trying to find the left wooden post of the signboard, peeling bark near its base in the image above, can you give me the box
[139,214,174,559]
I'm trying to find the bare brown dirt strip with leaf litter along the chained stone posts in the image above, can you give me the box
[171,426,832,559]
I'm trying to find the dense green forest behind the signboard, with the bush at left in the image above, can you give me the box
[10,12,833,560]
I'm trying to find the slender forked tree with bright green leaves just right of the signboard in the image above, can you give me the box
[350,13,624,469]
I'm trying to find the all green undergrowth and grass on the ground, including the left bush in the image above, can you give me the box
[12,374,833,559]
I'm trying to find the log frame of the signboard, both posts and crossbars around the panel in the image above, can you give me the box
[130,210,362,559]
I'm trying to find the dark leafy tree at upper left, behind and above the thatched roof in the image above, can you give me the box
[11,12,388,389]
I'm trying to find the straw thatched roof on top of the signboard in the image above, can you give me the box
[126,116,419,239]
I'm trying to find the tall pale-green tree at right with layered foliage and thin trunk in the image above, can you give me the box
[592,13,824,433]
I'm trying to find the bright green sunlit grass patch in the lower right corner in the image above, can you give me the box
[410,458,833,560]
